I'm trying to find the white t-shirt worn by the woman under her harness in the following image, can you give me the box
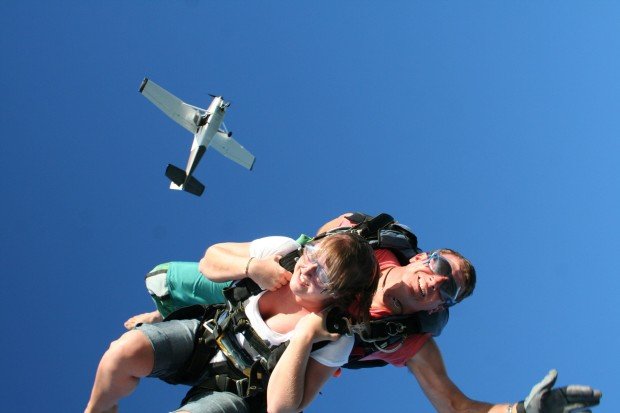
[211,236,354,367]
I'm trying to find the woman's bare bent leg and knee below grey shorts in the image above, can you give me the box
[85,330,155,413]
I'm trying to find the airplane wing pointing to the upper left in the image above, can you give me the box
[140,78,206,133]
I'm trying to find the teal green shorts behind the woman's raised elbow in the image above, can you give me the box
[145,261,232,317]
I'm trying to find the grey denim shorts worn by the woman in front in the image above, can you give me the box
[136,320,249,413]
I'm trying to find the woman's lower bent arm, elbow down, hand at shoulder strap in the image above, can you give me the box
[267,313,350,413]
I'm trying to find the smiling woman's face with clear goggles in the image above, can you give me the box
[290,243,333,304]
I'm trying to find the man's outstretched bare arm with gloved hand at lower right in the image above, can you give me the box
[407,339,602,413]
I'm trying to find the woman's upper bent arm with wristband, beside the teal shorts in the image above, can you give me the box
[198,237,296,291]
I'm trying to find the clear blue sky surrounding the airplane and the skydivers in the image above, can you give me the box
[0,0,620,413]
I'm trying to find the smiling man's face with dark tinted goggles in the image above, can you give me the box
[380,249,464,314]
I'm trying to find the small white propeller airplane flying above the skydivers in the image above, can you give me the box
[140,78,256,196]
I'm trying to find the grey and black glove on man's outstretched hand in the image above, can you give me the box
[517,370,602,413]
